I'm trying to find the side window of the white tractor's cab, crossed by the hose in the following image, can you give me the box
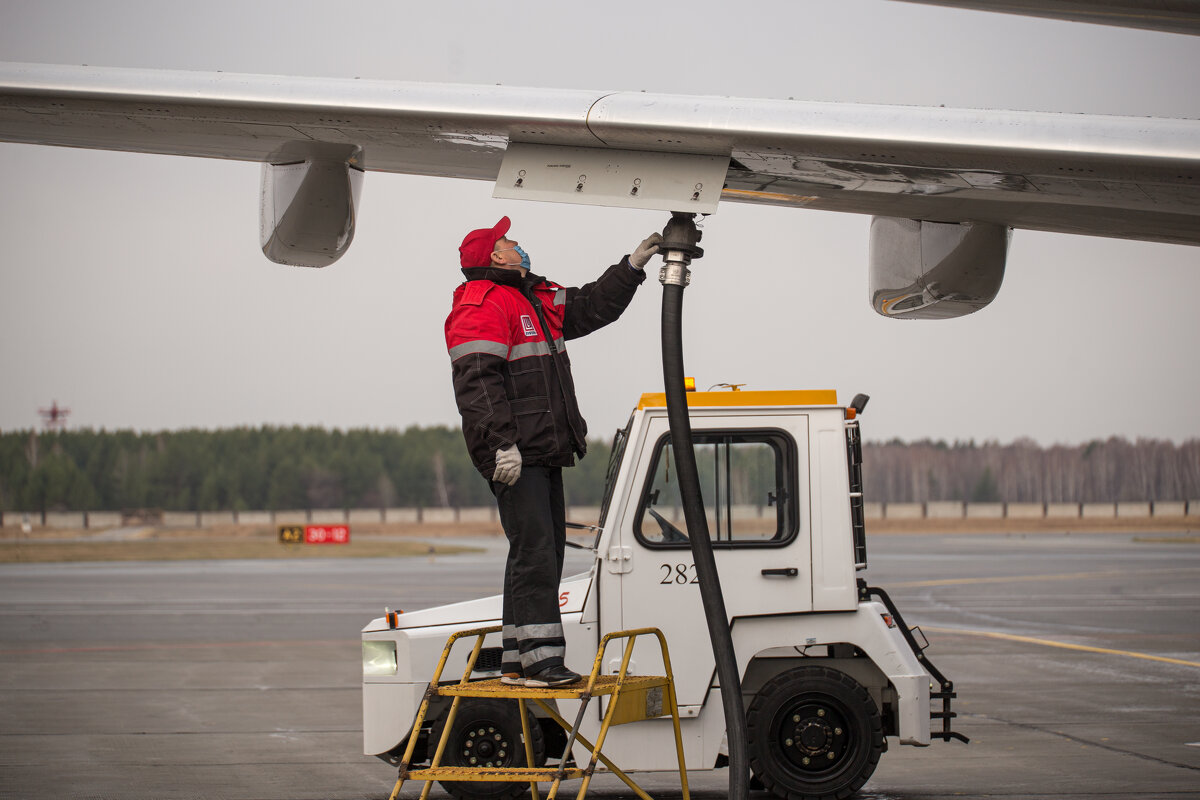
[634,431,799,548]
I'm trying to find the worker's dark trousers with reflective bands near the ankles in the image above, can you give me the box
[492,467,566,675]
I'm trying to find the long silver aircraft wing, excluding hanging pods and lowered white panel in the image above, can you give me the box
[0,64,1200,245]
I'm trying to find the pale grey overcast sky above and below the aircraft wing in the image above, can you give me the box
[0,0,1200,444]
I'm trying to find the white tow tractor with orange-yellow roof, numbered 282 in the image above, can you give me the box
[362,390,967,800]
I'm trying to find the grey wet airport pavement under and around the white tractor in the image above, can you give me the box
[0,534,1200,800]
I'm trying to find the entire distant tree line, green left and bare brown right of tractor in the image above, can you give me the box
[0,426,1200,511]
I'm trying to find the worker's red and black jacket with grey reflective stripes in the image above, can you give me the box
[445,257,646,480]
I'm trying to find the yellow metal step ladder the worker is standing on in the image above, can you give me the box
[389,625,690,800]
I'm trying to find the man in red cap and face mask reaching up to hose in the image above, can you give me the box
[445,217,662,686]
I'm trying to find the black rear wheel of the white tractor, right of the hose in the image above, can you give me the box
[746,667,883,800]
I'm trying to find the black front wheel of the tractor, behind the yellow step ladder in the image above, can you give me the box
[428,697,546,800]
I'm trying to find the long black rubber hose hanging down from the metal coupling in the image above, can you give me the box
[662,283,750,800]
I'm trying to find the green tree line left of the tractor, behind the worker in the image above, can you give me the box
[0,426,605,511]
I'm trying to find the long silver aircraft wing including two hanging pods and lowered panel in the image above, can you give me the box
[0,64,1200,317]
